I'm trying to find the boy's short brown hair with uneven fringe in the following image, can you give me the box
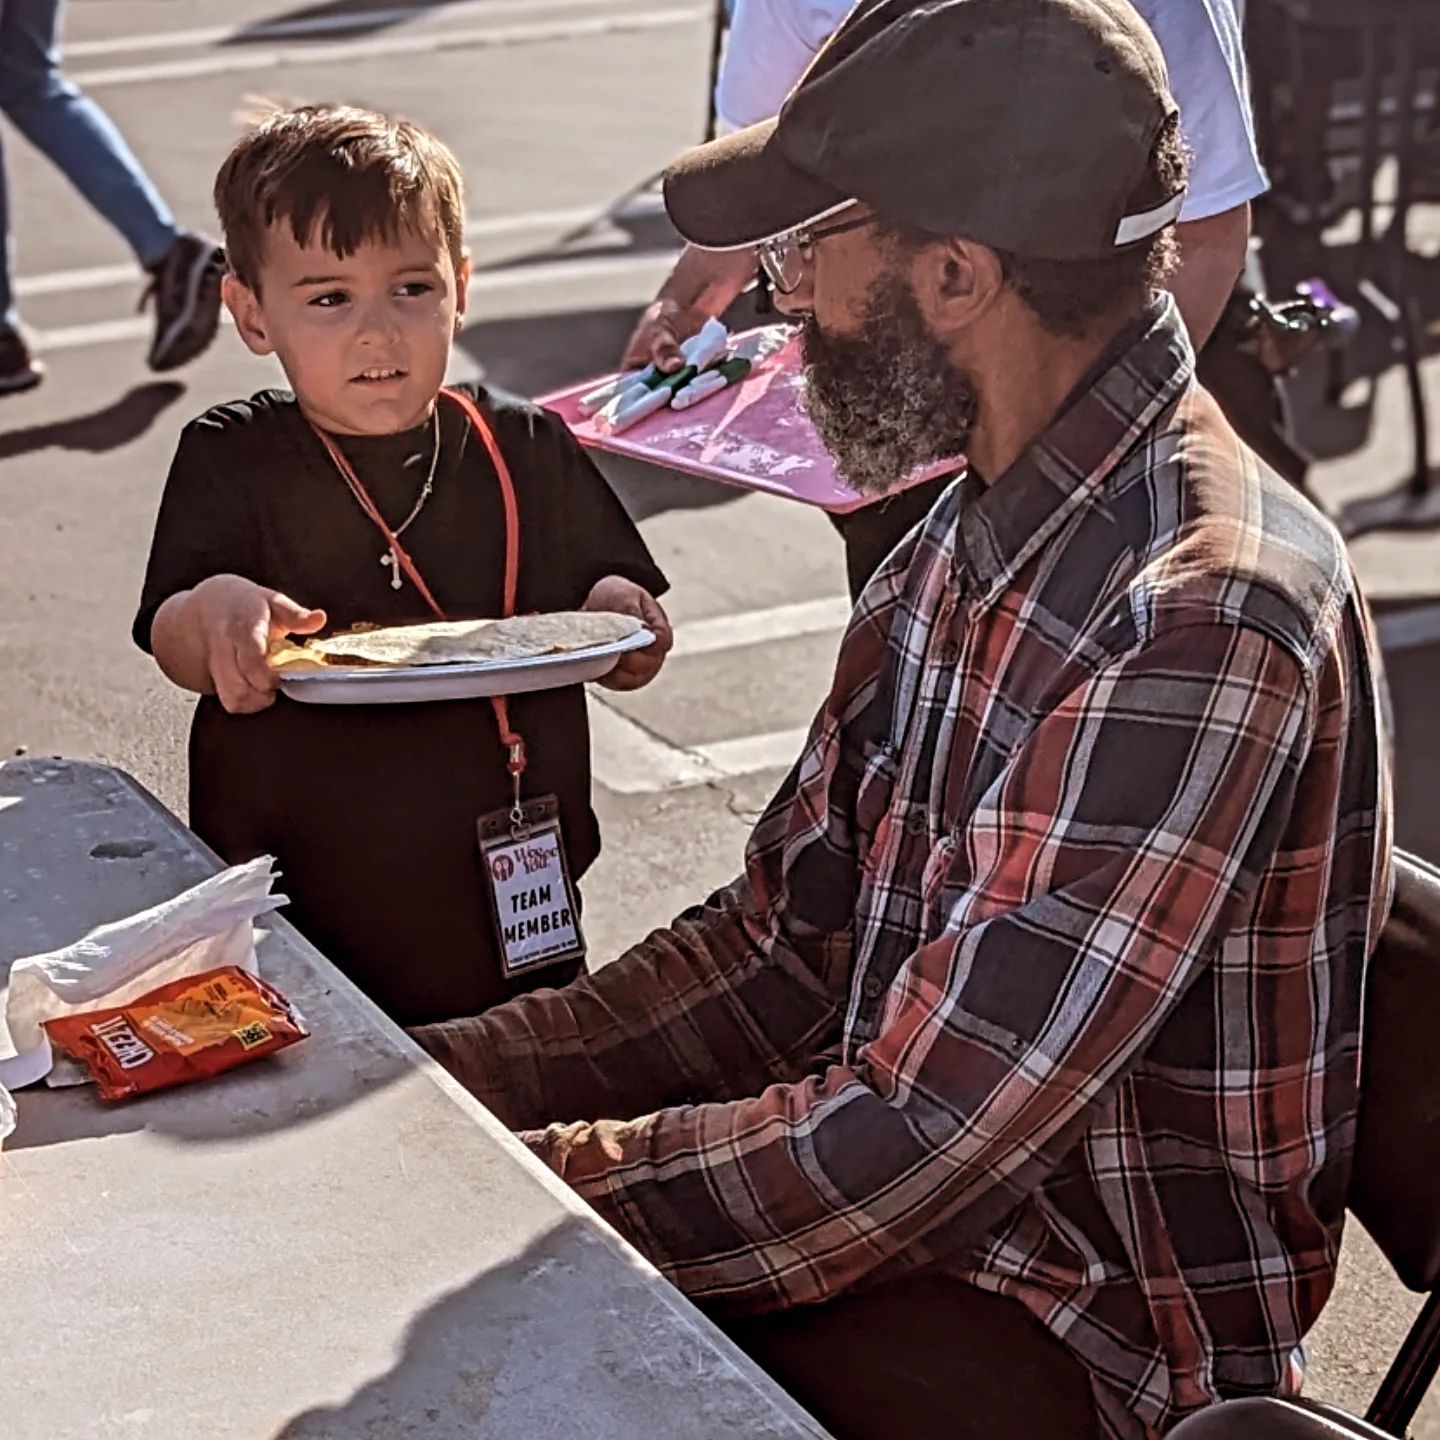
[215,105,465,294]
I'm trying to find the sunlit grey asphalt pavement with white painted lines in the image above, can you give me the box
[0,0,1440,1440]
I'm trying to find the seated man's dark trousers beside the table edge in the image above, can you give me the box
[719,1276,1099,1440]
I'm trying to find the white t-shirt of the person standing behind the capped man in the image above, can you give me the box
[716,0,1269,220]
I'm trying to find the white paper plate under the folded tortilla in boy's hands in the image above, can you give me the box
[279,629,655,706]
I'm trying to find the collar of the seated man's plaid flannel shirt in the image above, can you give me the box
[955,294,1195,595]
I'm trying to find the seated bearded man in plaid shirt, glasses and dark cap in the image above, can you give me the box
[419,0,1391,1440]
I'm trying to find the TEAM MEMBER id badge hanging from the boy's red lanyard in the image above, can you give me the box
[478,795,585,979]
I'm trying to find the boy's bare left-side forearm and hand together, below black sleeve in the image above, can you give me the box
[150,575,325,714]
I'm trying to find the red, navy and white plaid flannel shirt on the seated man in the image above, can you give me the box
[420,301,1390,1436]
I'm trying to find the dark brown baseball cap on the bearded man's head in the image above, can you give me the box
[665,0,1184,259]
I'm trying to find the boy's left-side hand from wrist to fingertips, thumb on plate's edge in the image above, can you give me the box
[187,575,325,714]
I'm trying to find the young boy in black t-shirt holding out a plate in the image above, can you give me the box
[134,108,671,1025]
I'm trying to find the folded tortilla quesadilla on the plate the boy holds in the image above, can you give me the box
[269,611,644,672]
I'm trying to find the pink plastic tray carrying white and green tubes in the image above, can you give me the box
[539,331,953,514]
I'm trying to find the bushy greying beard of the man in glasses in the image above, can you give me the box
[801,275,978,497]
